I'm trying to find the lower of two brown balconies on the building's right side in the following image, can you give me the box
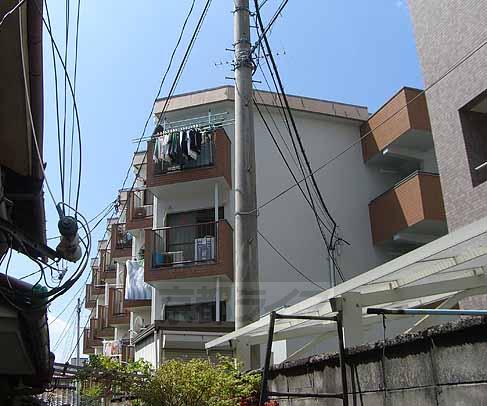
[369,172,447,248]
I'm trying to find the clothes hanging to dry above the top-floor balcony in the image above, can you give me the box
[153,128,213,171]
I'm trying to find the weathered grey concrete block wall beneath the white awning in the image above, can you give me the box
[269,318,487,406]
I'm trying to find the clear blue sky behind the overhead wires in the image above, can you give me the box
[1,0,423,361]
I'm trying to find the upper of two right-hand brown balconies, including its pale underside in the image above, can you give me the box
[360,88,434,173]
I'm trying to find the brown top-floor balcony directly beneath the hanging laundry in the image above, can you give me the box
[147,129,232,194]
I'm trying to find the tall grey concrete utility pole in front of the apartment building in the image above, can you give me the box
[234,0,260,334]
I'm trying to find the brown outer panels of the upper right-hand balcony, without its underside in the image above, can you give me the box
[360,88,431,161]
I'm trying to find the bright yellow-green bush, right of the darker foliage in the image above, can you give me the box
[139,358,260,406]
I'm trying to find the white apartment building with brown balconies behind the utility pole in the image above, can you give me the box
[84,86,446,365]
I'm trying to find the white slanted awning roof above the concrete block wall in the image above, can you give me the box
[206,217,487,349]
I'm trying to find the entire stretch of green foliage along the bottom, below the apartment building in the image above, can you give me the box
[77,355,260,406]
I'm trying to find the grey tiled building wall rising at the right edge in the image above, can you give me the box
[409,0,487,308]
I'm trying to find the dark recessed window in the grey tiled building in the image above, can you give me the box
[460,91,487,187]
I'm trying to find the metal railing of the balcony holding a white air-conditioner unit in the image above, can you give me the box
[152,222,218,268]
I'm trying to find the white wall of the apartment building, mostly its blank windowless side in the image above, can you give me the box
[148,102,412,360]
